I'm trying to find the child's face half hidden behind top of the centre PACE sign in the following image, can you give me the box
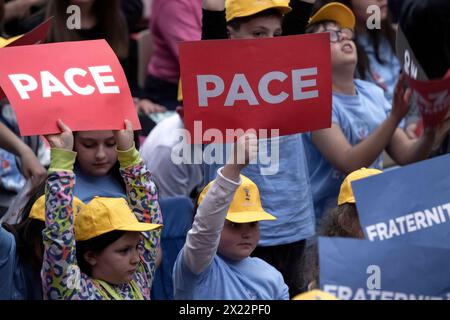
[228,15,281,39]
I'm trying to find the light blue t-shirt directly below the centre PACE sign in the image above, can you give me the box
[204,134,315,246]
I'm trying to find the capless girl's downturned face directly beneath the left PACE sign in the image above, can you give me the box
[74,131,117,176]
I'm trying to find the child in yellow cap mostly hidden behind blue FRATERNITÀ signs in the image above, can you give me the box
[303,168,382,290]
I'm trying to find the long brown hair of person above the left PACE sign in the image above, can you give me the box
[46,0,129,59]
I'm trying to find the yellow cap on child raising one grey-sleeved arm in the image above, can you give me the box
[197,175,277,223]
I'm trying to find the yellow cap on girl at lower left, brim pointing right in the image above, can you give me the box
[75,197,162,241]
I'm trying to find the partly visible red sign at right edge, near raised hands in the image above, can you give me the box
[408,72,450,127]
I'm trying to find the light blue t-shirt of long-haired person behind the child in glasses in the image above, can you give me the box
[358,34,401,103]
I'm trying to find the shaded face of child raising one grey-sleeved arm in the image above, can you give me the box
[218,220,259,261]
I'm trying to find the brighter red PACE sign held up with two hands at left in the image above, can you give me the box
[0,40,140,136]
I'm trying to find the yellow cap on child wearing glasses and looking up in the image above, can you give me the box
[308,2,356,30]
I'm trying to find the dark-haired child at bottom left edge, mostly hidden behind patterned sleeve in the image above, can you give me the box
[0,183,83,300]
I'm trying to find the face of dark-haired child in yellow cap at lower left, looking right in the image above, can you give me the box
[90,232,141,284]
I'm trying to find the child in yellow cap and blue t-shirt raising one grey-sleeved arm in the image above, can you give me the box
[173,135,289,300]
